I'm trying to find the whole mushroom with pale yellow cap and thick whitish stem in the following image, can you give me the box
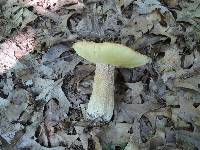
[73,41,151,122]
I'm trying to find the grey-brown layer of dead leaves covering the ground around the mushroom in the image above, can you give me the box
[0,0,200,150]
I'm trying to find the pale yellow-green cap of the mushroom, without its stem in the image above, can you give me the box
[73,41,151,68]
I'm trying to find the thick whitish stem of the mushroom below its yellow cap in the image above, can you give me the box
[87,64,114,121]
